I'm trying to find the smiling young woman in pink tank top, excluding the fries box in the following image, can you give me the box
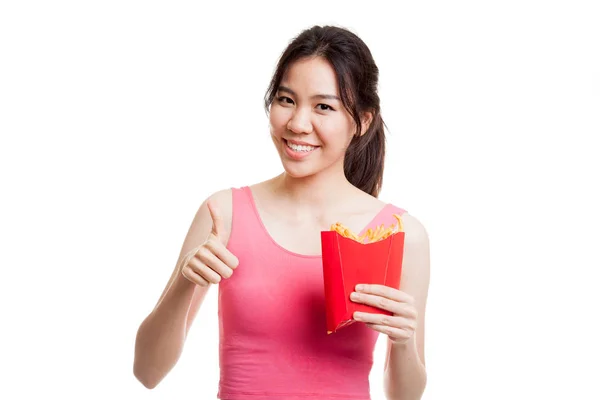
[134,26,429,400]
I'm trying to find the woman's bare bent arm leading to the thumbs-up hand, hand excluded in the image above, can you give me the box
[133,190,232,389]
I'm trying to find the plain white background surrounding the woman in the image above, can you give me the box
[0,0,600,400]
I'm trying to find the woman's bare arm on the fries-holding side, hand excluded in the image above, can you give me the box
[384,214,430,400]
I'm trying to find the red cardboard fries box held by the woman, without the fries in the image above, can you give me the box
[321,231,404,333]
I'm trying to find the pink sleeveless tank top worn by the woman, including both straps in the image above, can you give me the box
[217,186,405,400]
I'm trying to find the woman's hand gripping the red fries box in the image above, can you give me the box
[350,285,418,344]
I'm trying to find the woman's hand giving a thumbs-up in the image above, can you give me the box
[181,201,239,286]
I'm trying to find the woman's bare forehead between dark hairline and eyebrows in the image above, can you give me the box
[281,57,339,95]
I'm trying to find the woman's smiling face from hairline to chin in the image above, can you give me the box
[269,57,356,178]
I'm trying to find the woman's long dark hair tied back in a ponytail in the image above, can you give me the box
[265,25,385,197]
